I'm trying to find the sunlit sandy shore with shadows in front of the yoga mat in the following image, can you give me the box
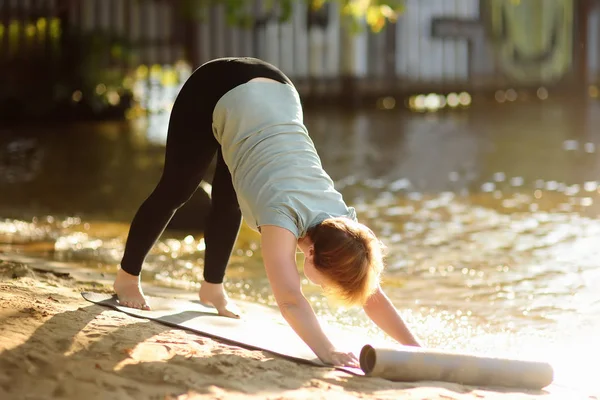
[0,253,596,400]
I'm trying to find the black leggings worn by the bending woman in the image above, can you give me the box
[121,57,293,283]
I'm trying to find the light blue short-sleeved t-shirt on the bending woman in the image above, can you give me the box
[213,81,356,238]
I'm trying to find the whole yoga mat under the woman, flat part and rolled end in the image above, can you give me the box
[82,293,553,389]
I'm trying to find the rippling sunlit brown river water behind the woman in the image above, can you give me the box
[0,100,600,391]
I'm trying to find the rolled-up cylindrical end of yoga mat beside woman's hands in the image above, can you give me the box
[359,345,554,389]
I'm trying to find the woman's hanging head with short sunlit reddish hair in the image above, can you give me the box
[300,217,383,305]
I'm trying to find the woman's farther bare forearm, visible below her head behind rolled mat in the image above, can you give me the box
[363,287,421,347]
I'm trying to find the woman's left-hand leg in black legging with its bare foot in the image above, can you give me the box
[114,84,218,308]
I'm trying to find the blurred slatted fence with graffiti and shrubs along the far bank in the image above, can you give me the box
[0,0,600,120]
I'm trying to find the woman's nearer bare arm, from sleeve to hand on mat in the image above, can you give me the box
[261,225,358,366]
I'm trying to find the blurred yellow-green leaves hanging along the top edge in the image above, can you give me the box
[181,0,404,32]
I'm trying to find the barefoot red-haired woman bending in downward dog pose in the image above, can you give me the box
[114,57,419,366]
